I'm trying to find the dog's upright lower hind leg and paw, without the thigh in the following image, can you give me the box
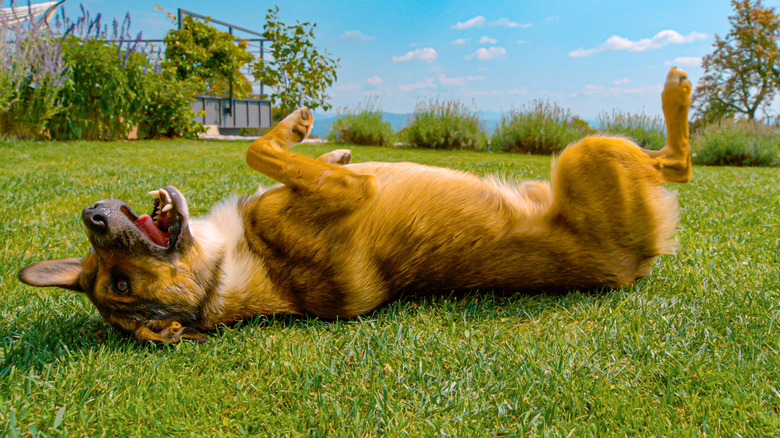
[643,67,691,183]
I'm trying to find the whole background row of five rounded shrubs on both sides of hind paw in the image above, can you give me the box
[328,99,780,166]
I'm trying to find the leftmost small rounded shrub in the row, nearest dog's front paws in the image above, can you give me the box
[328,100,395,146]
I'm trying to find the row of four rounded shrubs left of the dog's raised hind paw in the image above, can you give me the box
[327,99,648,154]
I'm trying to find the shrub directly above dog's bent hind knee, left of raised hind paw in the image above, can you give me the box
[598,110,666,151]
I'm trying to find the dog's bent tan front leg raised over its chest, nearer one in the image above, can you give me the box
[246,108,376,209]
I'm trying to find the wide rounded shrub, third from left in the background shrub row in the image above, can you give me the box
[491,100,591,154]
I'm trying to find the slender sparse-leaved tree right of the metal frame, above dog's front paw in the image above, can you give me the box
[254,6,338,115]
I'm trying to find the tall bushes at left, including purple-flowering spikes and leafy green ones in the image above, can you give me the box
[0,9,210,140]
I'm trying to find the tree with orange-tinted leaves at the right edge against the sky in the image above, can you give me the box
[694,0,780,122]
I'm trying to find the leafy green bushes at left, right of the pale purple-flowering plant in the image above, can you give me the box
[48,37,202,140]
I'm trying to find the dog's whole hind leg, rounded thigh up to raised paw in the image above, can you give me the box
[548,68,691,286]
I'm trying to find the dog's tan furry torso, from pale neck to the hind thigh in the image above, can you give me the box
[191,163,572,322]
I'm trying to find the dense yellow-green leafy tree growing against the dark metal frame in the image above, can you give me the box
[163,16,254,98]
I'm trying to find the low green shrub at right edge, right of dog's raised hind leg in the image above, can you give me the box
[691,120,780,166]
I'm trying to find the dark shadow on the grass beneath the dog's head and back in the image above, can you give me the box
[0,289,615,376]
